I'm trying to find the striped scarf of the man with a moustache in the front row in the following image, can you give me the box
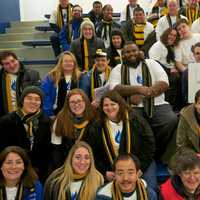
[111,179,148,200]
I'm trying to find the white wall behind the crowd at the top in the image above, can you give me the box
[20,0,154,21]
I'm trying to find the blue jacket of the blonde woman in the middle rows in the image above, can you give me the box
[40,75,84,116]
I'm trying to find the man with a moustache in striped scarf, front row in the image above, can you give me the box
[96,154,157,200]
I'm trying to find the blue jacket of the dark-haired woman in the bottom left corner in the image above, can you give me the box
[24,181,43,200]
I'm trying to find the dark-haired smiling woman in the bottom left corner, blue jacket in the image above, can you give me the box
[0,146,42,200]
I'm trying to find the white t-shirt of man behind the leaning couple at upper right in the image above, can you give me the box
[155,15,187,40]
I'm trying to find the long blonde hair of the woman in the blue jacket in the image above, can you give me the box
[49,51,81,86]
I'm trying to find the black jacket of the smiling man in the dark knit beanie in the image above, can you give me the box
[0,112,51,181]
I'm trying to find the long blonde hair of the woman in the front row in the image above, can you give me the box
[48,141,104,200]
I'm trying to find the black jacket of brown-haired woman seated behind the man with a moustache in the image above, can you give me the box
[89,111,155,175]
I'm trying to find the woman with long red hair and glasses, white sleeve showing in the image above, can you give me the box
[51,89,97,169]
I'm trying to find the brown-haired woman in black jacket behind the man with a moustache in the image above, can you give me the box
[91,91,157,191]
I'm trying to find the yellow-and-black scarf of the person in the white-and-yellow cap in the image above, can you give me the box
[90,65,111,100]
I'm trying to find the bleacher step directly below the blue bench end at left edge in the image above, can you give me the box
[0,31,52,41]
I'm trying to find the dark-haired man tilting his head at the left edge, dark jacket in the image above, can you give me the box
[0,51,40,116]
